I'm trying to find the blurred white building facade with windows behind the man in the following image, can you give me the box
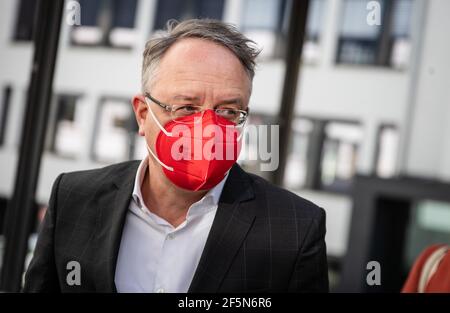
[0,0,450,292]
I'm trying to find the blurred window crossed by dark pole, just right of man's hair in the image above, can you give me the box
[241,0,325,63]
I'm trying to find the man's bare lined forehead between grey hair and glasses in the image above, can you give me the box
[151,38,250,91]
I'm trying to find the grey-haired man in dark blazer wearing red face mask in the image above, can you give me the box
[24,20,328,292]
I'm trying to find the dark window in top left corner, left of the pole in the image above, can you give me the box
[13,0,37,41]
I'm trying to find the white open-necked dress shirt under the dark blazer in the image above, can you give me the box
[115,157,228,293]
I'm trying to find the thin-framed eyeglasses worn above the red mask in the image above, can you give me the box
[145,92,248,126]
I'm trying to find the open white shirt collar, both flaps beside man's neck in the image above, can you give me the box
[132,156,229,217]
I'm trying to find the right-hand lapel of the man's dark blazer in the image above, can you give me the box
[189,164,256,292]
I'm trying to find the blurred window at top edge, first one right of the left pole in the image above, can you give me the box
[71,0,137,48]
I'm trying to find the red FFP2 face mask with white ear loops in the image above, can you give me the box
[147,108,241,191]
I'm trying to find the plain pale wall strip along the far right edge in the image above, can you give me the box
[405,0,450,181]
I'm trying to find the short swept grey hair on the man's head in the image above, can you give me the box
[142,19,261,91]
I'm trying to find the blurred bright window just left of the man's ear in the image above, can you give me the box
[93,98,137,163]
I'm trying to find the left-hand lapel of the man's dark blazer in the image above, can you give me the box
[95,162,139,292]
